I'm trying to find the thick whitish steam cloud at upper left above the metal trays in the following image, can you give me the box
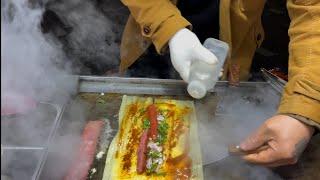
[1,0,75,106]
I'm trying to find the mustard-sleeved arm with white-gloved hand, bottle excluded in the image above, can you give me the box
[122,0,217,82]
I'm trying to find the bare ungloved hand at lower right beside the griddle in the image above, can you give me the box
[240,115,314,167]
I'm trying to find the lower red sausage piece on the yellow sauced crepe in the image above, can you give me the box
[137,130,149,174]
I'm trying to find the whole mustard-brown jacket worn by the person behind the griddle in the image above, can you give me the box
[120,0,320,125]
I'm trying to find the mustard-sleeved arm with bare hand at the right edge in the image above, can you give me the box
[240,0,320,167]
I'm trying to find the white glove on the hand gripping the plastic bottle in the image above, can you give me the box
[169,28,218,82]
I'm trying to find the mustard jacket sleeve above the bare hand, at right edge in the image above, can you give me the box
[278,0,320,124]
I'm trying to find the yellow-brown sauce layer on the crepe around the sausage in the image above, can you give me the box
[115,100,192,179]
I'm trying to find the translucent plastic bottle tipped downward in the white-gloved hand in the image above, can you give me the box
[187,38,229,99]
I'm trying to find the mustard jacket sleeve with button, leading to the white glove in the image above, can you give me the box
[122,0,191,53]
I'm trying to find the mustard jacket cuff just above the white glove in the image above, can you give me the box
[151,15,191,54]
